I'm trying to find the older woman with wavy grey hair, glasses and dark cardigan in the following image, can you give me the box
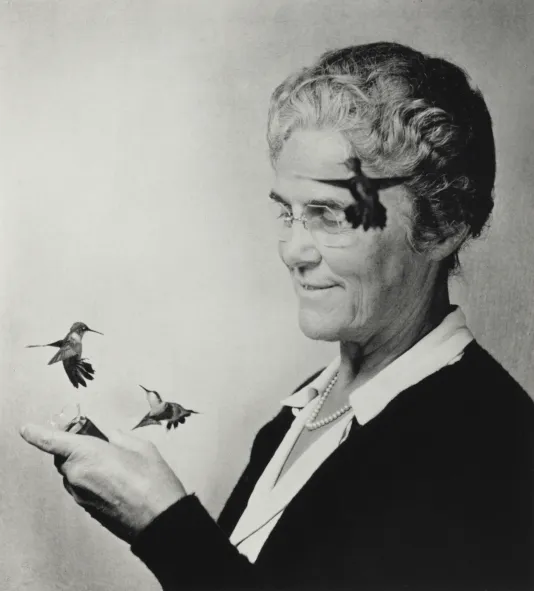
[23,43,534,590]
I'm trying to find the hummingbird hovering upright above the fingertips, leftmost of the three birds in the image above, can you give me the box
[27,322,102,388]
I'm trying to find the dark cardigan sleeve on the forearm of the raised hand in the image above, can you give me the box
[131,495,262,591]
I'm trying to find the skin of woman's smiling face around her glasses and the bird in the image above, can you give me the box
[273,130,437,346]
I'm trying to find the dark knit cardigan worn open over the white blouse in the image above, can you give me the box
[132,342,534,591]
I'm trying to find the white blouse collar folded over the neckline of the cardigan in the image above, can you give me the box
[281,307,474,425]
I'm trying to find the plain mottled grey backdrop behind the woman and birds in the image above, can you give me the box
[0,0,534,591]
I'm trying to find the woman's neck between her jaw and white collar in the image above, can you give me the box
[337,283,450,390]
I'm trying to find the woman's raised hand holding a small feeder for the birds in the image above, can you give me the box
[21,425,186,543]
